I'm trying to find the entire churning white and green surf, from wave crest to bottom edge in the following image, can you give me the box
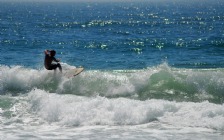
[0,64,224,140]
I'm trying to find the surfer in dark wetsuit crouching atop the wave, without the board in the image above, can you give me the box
[44,50,62,72]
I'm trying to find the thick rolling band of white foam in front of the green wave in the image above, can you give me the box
[29,89,224,131]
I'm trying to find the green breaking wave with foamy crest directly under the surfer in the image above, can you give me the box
[0,63,224,104]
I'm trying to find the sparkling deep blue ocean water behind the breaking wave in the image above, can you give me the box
[0,1,224,69]
